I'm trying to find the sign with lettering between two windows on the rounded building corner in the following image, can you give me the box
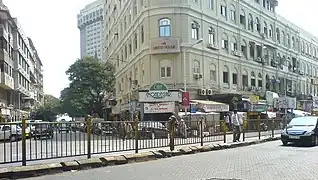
[150,38,180,54]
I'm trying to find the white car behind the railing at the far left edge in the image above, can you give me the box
[0,124,22,141]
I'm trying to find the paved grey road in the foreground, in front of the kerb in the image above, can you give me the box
[25,141,318,180]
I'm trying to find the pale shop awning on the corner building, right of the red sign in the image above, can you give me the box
[191,100,230,112]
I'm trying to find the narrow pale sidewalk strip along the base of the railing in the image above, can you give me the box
[0,133,280,168]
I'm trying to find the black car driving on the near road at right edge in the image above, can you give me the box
[281,116,318,146]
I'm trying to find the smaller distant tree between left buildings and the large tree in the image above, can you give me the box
[31,94,61,121]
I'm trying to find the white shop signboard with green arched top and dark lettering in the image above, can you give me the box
[139,82,182,102]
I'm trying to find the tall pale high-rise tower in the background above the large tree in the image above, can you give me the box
[77,0,104,59]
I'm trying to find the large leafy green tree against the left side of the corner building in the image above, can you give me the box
[60,57,115,117]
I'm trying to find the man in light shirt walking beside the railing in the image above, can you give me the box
[225,109,243,142]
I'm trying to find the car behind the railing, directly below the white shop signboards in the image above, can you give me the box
[138,121,169,139]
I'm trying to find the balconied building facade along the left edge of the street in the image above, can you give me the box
[0,1,43,121]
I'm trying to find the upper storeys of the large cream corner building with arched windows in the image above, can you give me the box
[104,0,318,109]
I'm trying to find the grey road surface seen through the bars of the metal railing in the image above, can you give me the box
[0,131,279,167]
